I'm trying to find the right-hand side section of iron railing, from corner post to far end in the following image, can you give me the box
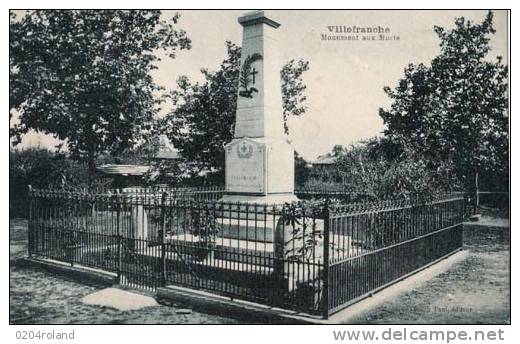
[326,196,465,313]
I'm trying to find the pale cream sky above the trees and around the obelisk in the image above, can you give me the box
[13,10,508,160]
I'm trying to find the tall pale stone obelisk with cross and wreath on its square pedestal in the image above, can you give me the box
[222,11,296,204]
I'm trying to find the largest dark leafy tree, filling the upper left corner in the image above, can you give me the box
[9,10,191,185]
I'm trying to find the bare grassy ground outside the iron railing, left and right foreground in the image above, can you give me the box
[10,217,510,324]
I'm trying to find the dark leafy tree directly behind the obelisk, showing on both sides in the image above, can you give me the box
[158,42,309,180]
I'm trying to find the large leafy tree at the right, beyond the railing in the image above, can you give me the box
[380,12,508,196]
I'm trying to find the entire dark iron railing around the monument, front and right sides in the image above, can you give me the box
[29,188,465,317]
